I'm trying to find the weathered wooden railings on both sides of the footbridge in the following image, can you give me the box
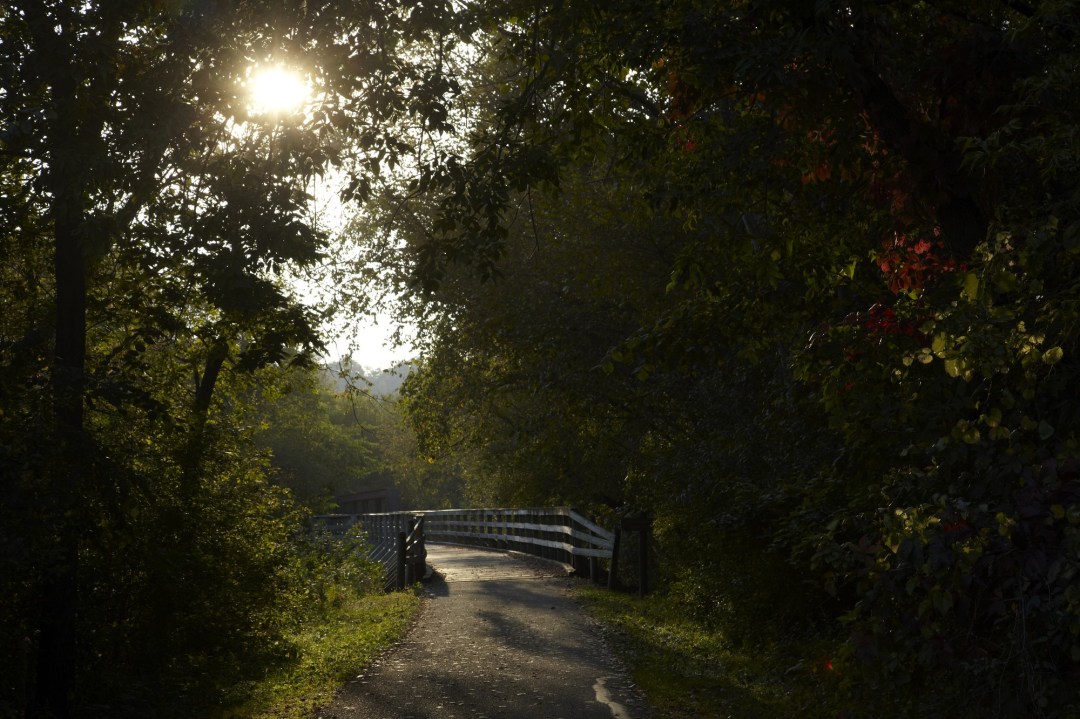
[315,507,615,588]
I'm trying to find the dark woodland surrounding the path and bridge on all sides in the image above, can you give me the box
[0,0,1080,717]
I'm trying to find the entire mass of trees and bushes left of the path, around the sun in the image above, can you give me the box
[0,0,470,717]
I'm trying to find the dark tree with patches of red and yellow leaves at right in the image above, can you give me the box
[358,0,1080,716]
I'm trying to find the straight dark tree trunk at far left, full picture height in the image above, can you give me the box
[28,6,93,703]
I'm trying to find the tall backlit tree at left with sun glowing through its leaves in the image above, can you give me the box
[0,0,470,717]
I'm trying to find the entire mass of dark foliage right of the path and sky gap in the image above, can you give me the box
[356,0,1080,717]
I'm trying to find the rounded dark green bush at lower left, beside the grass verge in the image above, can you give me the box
[79,455,296,716]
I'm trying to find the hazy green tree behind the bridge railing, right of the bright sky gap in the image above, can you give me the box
[345,150,671,504]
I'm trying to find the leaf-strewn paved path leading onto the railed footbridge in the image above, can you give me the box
[315,545,648,719]
